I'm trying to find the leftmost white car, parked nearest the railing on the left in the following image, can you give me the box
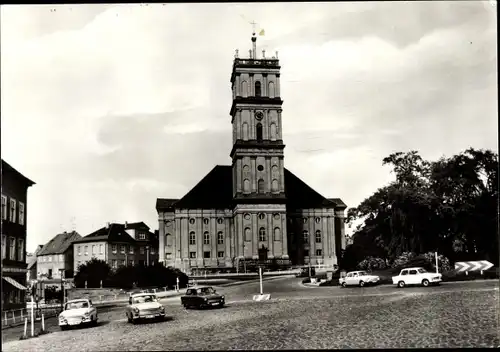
[59,299,97,330]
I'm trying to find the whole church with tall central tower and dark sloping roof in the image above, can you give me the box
[156,33,347,271]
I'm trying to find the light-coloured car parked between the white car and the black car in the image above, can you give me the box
[125,293,165,324]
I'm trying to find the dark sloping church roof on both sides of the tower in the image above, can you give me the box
[156,165,347,211]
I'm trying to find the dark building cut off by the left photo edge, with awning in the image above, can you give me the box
[2,159,35,310]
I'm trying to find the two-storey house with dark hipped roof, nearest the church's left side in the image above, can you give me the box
[73,222,158,273]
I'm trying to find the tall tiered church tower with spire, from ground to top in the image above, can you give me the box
[230,32,288,260]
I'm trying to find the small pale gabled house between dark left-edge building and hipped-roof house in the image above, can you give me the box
[37,231,82,280]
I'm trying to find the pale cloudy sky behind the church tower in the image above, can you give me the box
[1,1,498,251]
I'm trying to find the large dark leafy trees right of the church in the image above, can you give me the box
[344,148,498,264]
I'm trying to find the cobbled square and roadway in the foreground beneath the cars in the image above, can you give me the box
[2,277,500,352]
